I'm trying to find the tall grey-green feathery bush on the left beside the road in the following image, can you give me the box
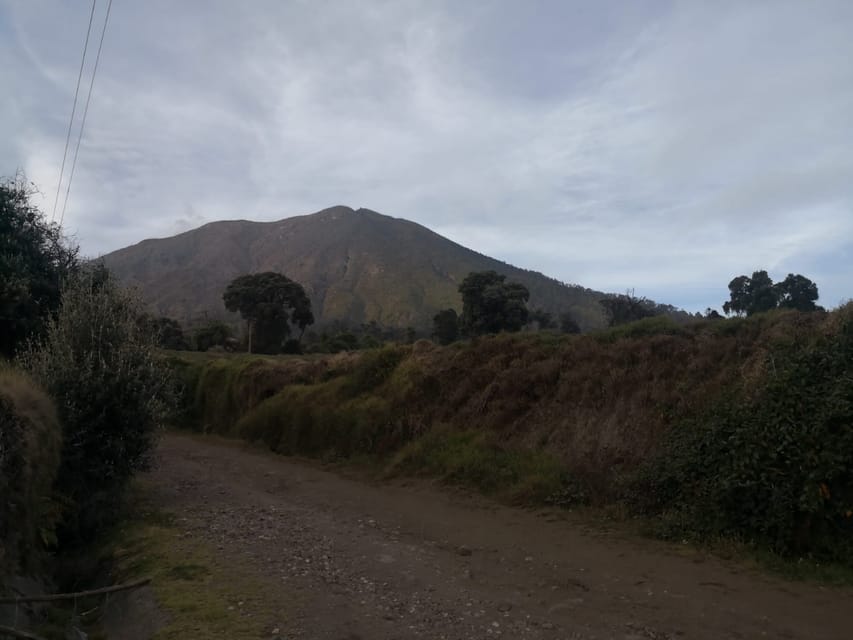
[21,269,170,542]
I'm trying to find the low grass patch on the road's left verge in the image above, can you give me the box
[106,486,290,640]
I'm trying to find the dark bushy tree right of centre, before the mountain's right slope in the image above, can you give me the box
[459,271,530,336]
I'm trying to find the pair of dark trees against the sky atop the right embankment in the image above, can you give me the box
[723,270,821,316]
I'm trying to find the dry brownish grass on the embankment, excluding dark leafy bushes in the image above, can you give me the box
[170,313,827,500]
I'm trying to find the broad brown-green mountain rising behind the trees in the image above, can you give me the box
[103,206,604,330]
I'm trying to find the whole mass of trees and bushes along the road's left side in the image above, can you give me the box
[0,177,172,638]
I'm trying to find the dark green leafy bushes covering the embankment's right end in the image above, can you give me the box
[640,306,853,562]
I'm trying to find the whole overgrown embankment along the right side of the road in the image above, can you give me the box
[165,305,853,576]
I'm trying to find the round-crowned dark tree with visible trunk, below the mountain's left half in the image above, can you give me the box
[222,271,314,353]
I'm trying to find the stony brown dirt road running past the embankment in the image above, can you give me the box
[147,435,853,640]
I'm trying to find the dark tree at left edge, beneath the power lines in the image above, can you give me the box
[0,174,79,357]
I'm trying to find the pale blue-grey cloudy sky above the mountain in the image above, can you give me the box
[0,0,853,311]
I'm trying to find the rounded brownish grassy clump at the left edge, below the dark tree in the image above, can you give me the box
[0,365,62,575]
